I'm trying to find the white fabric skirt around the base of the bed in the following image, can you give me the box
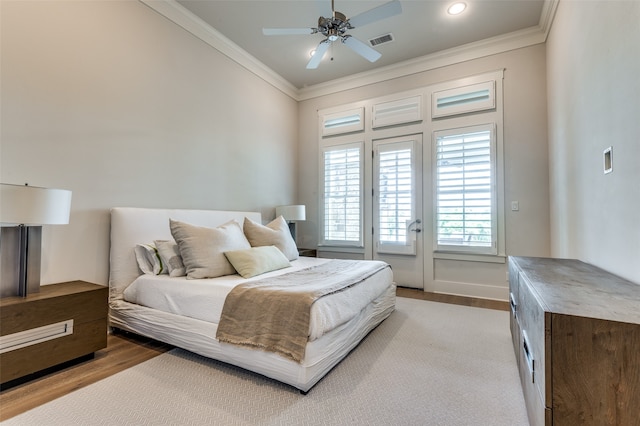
[110,286,396,392]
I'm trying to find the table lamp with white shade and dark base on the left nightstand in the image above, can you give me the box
[0,183,71,297]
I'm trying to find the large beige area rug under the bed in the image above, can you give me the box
[3,298,528,426]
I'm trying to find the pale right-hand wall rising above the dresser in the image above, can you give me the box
[547,1,640,284]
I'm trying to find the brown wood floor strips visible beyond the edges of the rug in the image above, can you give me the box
[0,288,509,421]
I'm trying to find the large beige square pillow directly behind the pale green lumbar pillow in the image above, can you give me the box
[169,219,251,278]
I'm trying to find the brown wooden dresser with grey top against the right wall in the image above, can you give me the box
[509,257,640,426]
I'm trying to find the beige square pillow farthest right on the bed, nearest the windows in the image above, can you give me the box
[244,216,298,260]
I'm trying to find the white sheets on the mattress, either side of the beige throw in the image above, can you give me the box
[124,257,392,341]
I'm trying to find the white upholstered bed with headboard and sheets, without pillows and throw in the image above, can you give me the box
[109,207,395,392]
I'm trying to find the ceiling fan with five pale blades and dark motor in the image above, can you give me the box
[262,0,402,69]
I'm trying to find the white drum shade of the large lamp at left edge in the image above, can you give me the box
[0,183,71,226]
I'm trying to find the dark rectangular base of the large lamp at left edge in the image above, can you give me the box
[0,226,42,297]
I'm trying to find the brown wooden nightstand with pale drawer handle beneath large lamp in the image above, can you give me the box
[0,281,109,384]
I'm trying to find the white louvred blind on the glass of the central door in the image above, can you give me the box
[378,148,413,245]
